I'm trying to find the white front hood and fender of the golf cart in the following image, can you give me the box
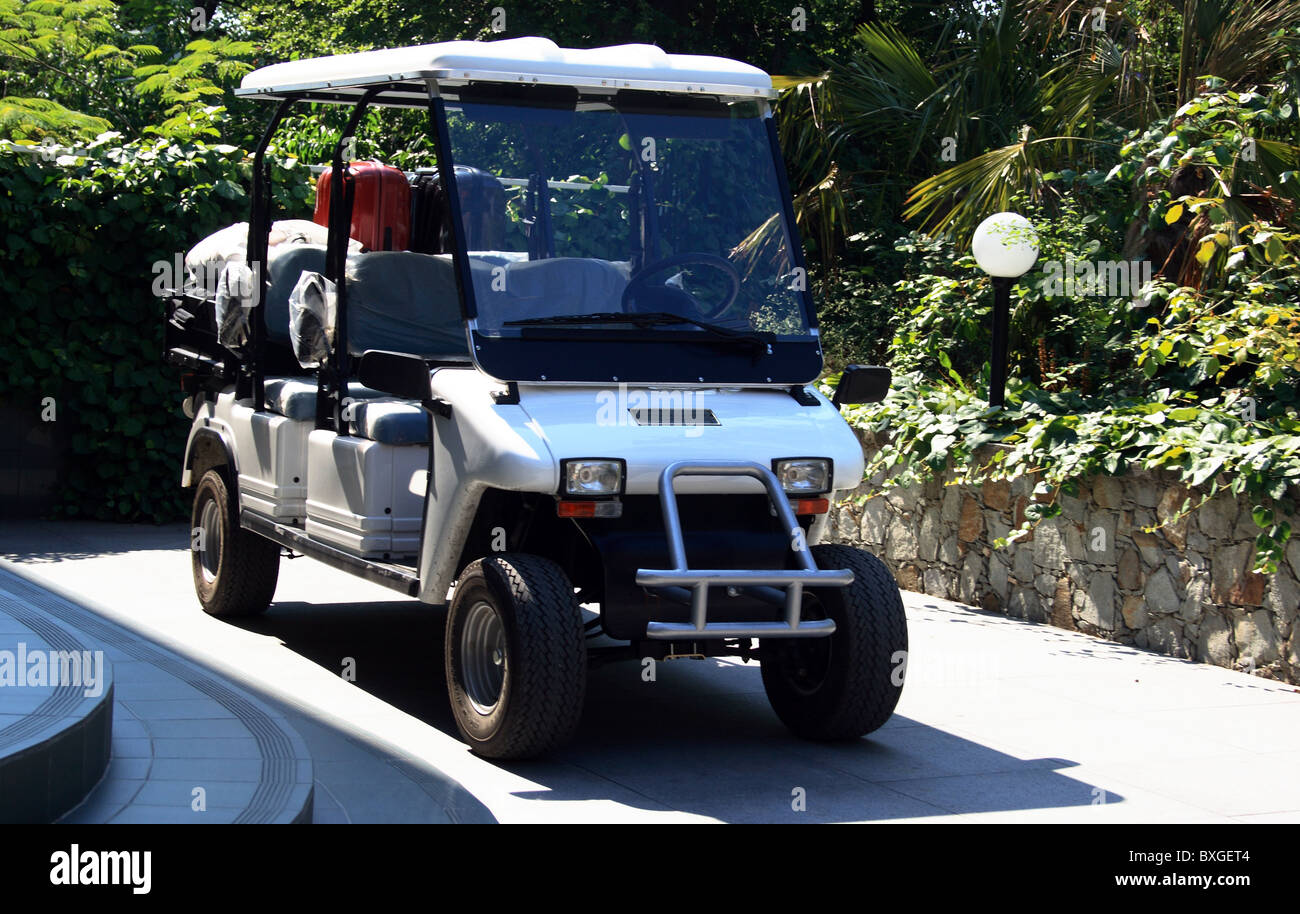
[420,369,863,603]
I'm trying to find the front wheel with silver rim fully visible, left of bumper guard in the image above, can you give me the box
[445,553,586,759]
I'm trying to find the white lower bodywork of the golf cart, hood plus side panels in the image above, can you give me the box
[183,368,863,603]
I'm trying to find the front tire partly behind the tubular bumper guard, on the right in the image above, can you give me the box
[759,545,907,740]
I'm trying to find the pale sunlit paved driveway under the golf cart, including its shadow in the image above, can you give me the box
[0,523,1300,822]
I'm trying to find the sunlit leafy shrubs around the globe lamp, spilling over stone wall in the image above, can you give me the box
[826,79,1300,572]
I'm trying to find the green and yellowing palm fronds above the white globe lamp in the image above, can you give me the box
[781,0,1300,252]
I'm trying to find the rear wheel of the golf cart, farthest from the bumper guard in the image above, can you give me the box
[190,469,280,619]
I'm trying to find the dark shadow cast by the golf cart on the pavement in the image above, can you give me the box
[241,601,1123,822]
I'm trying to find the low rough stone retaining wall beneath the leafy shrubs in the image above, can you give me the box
[828,445,1300,683]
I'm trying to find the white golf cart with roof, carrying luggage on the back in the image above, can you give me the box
[168,38,907,758]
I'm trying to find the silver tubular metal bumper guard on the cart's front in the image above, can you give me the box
[636,460,853,641]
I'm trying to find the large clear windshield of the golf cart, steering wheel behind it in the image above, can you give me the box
[447,92,810,341]
